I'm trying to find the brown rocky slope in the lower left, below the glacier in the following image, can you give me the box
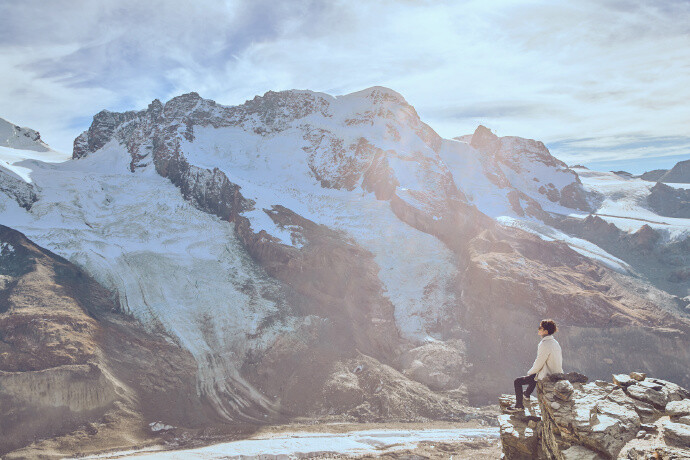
[0,225,212,457]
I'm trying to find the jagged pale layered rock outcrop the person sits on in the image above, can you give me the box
[499,372,690,460]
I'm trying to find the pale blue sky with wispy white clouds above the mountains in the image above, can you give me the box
[0,0,690,173]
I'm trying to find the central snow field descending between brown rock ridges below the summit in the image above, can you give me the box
[183,120,457,341]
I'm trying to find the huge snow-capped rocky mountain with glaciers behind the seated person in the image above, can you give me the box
[0,87,690,456]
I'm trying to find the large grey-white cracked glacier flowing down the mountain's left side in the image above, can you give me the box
[0,143,294,420]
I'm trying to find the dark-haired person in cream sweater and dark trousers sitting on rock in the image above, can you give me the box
[507,319,563,412]
